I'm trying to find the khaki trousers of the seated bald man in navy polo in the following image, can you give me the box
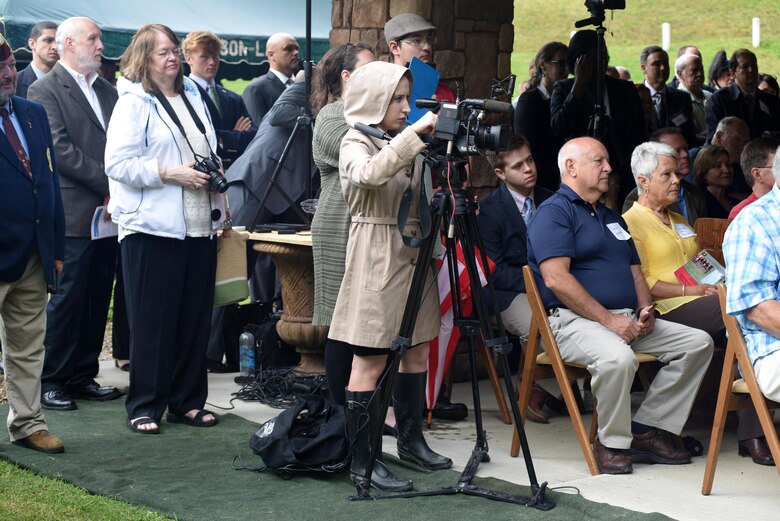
[550,308,713,449]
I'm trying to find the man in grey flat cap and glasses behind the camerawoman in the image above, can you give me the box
[385,13,456,103]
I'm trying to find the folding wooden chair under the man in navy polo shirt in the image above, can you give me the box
[509,266,657,476]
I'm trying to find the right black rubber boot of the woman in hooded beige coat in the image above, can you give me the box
[393,373,452,470]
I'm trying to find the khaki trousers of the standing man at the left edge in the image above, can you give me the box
[0,253,47,441]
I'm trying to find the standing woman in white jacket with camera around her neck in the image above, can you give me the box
[105,25,224,434]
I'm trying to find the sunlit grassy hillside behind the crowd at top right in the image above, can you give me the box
[512,0,780,85]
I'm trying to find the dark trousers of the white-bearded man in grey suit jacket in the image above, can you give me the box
[41,237,117,393]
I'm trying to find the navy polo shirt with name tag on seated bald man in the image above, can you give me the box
[528,185,639,309]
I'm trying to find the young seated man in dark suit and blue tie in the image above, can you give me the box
[477,136,555,423]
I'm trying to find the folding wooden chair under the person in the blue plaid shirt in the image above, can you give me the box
[697,286,780,496]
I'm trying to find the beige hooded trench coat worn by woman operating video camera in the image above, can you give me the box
[329,62,439,348]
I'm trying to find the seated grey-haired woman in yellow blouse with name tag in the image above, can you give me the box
[623,143,773,465]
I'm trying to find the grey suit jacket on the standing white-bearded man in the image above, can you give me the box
[28,62,117,237]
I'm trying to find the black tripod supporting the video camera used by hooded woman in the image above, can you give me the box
[350,160,555,510]
